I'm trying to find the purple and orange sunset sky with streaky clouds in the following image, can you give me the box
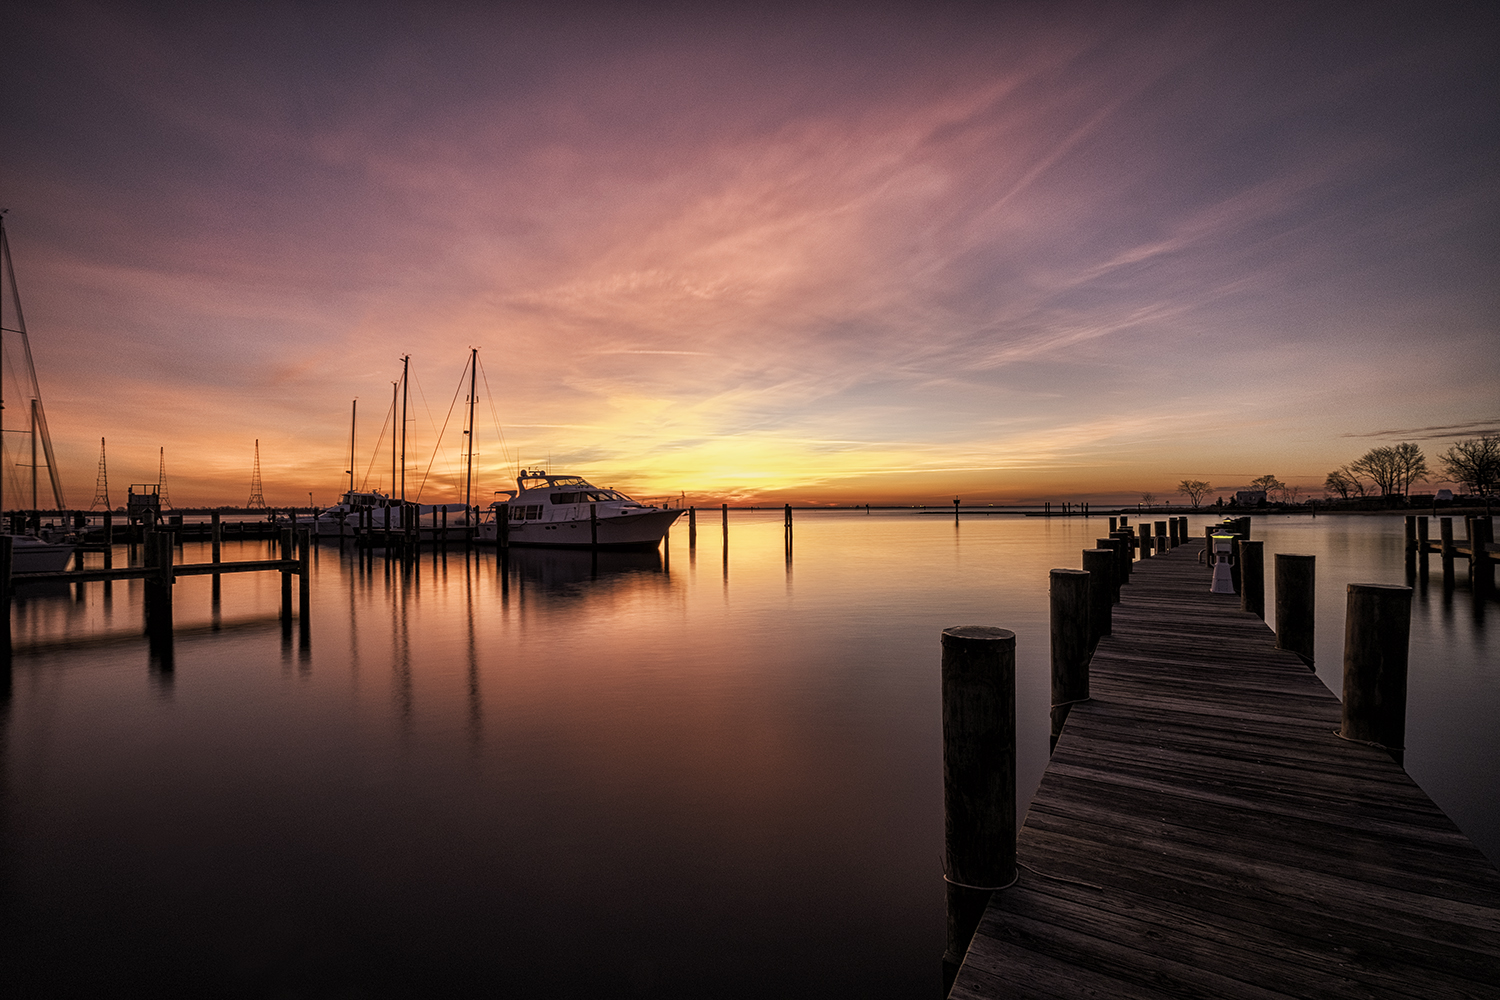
[0,0,1500,508]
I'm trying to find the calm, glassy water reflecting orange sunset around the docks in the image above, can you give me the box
[0,511,1500,997]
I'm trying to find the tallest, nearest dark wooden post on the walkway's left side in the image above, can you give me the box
[942,625,1016,996]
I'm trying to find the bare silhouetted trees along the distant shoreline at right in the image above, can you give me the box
[1170,435,1500,507]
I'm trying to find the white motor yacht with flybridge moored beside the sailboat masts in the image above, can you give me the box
[479,471,683,549]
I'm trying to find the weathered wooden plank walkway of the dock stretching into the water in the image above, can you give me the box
[951,540,1500,1000]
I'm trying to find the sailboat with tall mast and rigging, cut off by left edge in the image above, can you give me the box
[0,210,74,573]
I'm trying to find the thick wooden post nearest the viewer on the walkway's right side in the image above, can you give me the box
[1338,583,1412,763]
